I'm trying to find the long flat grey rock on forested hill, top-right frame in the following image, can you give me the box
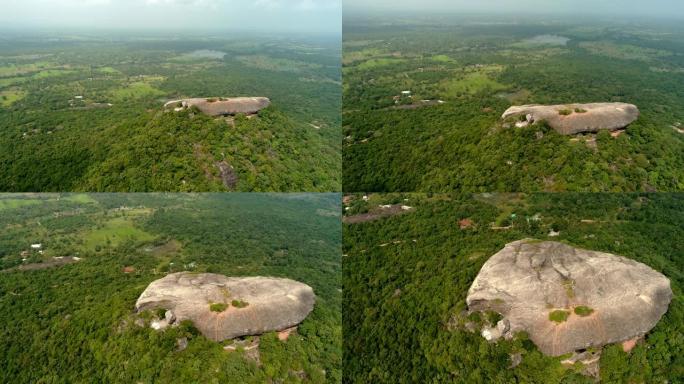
[501,103,639,135]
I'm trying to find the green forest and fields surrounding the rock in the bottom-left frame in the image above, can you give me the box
[0,193,342,384]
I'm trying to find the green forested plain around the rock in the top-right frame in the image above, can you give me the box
[342,15,684,192]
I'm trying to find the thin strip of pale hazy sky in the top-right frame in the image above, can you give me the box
[343,0,684,18]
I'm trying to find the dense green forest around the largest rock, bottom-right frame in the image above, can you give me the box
[342,193,684,384]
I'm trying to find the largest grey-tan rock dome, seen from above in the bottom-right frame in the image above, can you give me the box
[466,239,672,356]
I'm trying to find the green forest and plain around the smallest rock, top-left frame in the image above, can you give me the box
[0,35,342,192]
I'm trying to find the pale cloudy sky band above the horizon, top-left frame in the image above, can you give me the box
[0,0,342,35]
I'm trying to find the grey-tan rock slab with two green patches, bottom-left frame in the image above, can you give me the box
[135,272,315,341]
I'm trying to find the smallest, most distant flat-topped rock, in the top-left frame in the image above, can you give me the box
[164,97,271,116]
